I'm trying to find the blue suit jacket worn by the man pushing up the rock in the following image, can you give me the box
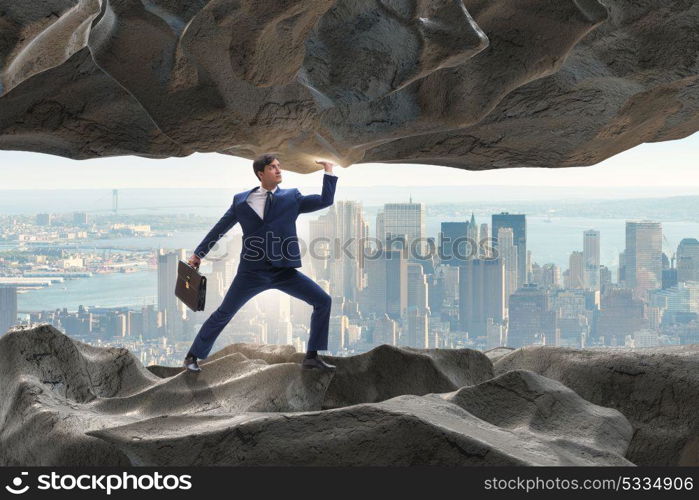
[194,174,337,269]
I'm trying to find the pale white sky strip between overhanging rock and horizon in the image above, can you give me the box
[0,133,699,190]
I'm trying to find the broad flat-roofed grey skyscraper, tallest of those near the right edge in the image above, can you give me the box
[625,221,663,302]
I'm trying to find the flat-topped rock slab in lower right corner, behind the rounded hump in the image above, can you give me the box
[494,345,699,466]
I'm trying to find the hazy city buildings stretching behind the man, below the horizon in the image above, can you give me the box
[0,190,699,361]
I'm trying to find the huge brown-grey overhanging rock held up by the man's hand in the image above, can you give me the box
[0,0,699,172]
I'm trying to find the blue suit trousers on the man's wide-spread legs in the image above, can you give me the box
[190,264,332,359]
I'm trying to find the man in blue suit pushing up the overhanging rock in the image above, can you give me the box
[184,154,337,372]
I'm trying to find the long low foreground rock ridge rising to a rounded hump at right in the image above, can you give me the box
[90,371,632,466]
